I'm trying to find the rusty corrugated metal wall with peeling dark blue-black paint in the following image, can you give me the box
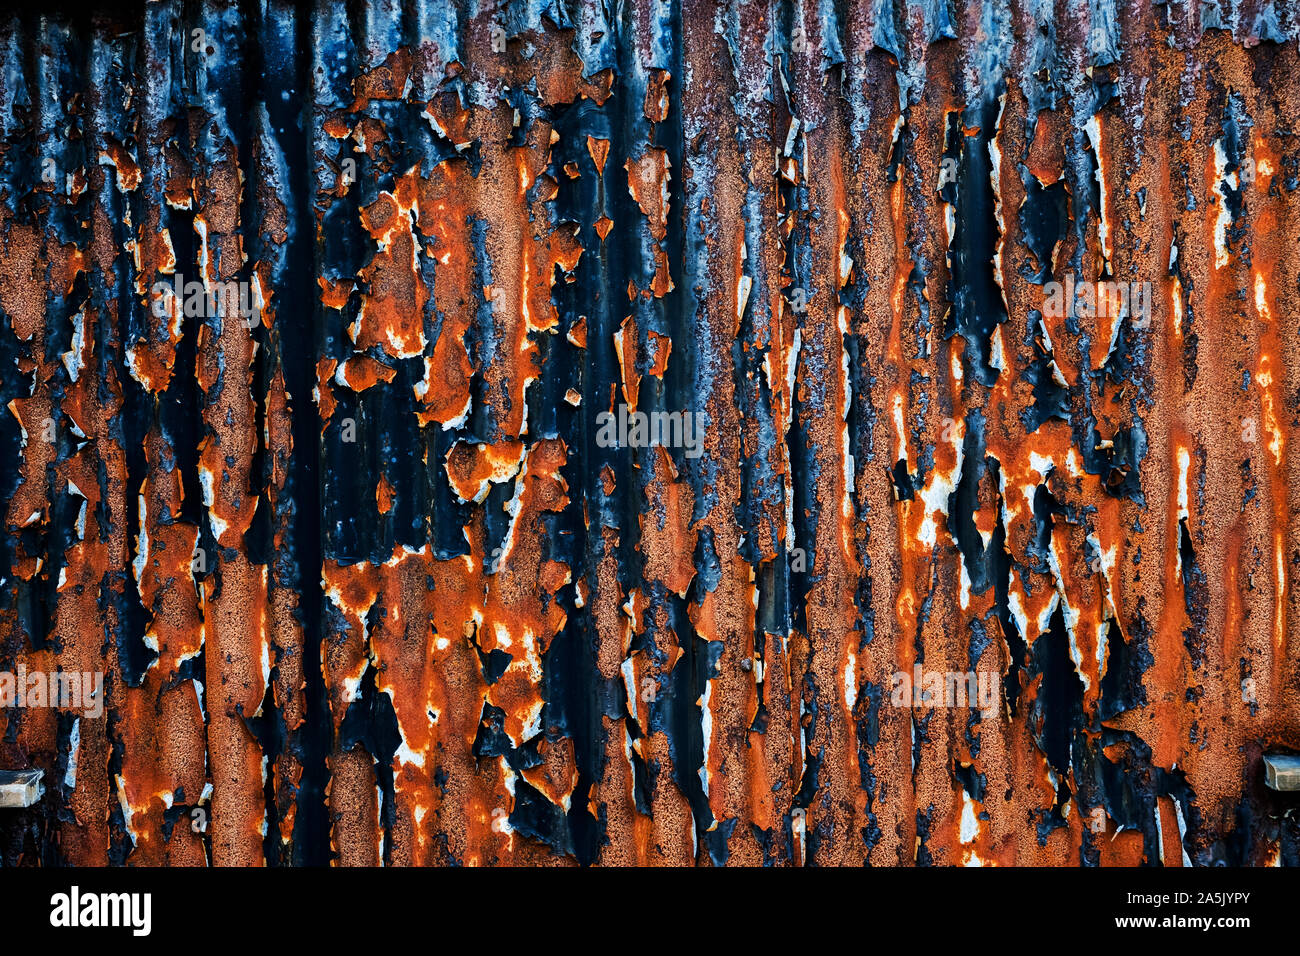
[0,0,1300,865]
